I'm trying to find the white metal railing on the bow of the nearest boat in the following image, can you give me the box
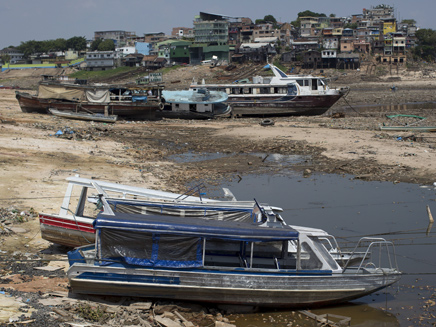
[343,237,398,273]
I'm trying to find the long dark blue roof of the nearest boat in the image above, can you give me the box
[94,213,299,241]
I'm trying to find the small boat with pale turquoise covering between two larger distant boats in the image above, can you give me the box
[157,89,232,119]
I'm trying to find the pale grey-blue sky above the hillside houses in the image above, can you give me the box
[0,0,436,49]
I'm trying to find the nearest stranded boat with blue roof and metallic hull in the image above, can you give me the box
[67,213,401,307]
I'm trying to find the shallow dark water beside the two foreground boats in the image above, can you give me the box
[199,174,436,326]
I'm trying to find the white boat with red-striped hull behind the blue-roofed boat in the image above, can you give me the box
[39,176,281,247]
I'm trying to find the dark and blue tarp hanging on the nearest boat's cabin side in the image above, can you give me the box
[100,229,202,268]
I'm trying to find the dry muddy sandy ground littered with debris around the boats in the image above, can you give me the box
[0,62,436,326]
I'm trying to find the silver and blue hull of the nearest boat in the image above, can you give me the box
[68,263,400,307]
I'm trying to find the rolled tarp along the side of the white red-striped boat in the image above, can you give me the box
[108,201,255,222]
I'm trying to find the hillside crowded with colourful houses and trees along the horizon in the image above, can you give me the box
[0,5,436,71]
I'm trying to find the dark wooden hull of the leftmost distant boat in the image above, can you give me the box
[15,91,158,119]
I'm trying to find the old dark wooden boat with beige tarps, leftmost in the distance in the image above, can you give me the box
[15,81,162,119]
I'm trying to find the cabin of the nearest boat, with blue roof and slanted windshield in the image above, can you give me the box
[90,213,340,274]
